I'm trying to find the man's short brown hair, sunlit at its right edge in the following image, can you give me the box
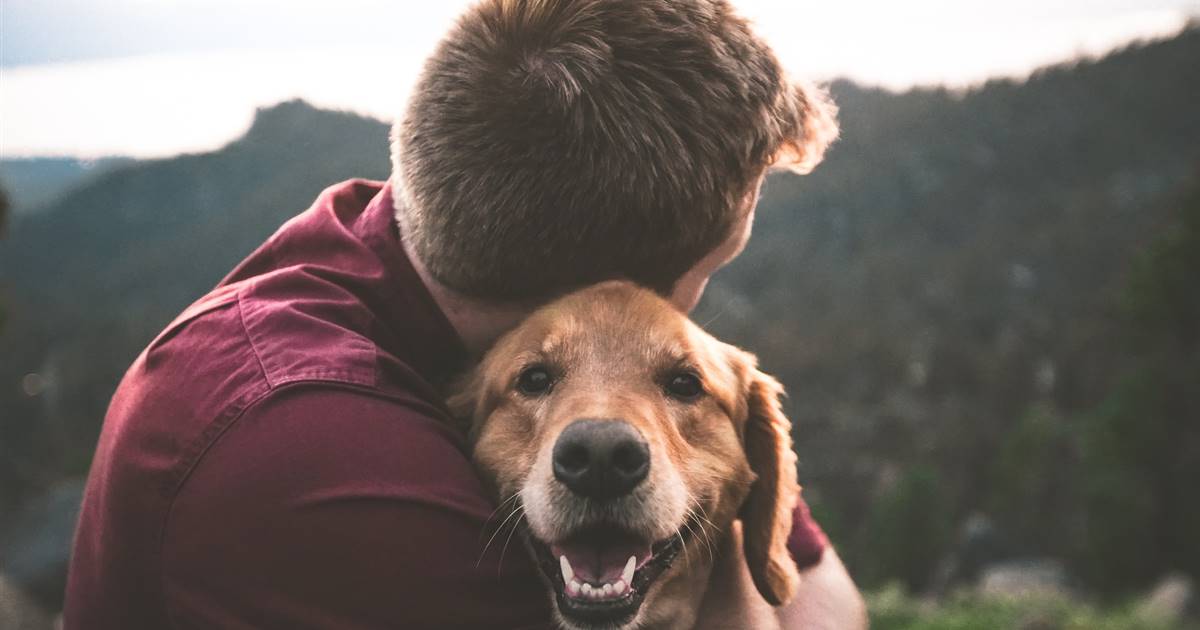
[392,0,836,300]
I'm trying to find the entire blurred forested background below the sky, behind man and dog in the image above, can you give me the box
[0,23,1200,629]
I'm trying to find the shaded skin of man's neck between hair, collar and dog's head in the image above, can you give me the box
[401,230,535,360]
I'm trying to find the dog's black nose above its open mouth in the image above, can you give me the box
[554,420,650,499]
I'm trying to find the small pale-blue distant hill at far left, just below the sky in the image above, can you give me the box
[0,157,132,214]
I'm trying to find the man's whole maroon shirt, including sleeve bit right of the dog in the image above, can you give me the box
[65,180,824,630]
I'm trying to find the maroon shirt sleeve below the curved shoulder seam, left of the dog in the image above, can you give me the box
[162,386,551,630]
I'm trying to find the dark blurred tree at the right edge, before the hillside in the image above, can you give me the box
[1080,176,1200,593]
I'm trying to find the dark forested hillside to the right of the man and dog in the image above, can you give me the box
[697,25,1200,595]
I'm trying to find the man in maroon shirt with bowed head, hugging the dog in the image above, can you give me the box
[65,0,863,629]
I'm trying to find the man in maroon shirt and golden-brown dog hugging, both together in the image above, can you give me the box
[65,0,865,629]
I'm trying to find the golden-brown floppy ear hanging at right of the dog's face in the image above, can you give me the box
[742,367,800,606]
